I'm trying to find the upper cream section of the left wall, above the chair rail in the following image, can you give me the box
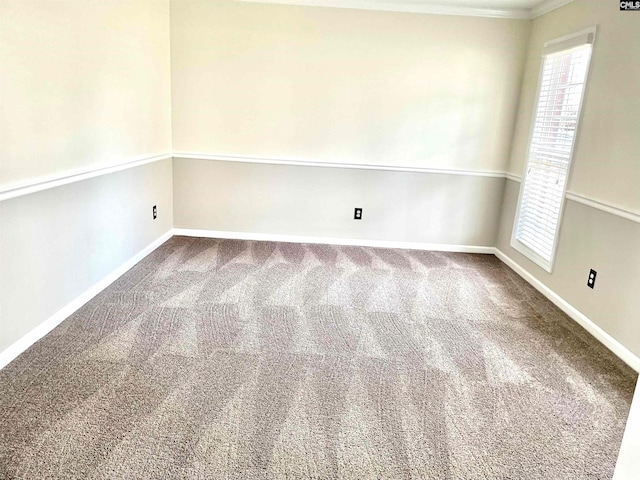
[0,0,171,187]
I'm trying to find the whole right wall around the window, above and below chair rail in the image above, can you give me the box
[497,0,640,356]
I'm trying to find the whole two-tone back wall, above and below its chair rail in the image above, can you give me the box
[171,1,530,246]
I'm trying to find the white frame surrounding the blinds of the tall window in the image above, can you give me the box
[511,25,597,273]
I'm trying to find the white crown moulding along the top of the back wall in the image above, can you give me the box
[236,0,533,20]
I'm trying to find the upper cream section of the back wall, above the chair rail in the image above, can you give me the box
[171,0,530,171]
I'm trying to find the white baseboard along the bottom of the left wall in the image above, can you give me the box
[0,230,173,369]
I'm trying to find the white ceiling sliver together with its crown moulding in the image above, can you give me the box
[236,0,573,18]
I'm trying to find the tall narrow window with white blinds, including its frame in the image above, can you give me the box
[511,27,595,272]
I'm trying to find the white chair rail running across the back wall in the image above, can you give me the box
[173,152,505,178]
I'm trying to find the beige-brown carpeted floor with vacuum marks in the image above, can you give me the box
[0,237,636,480]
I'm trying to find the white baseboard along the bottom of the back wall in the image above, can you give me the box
[173,228,494,254]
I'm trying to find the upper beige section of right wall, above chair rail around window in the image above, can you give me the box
[509,0,640,211]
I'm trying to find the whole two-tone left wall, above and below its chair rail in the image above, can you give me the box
[0,0,173,353]
